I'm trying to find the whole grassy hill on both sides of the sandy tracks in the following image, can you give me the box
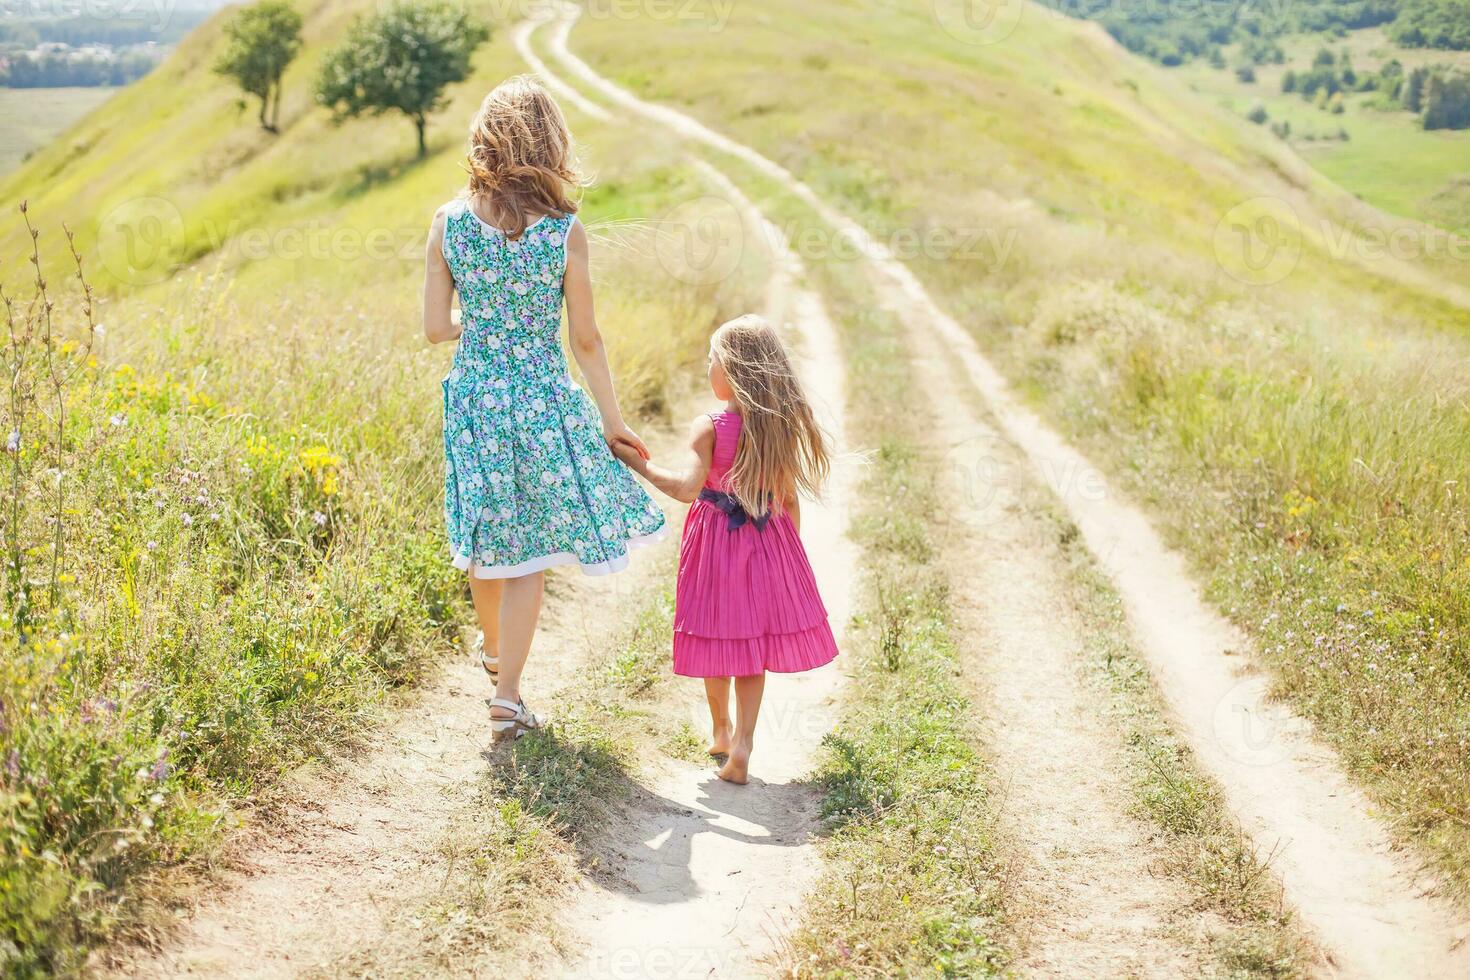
[0,0,1470,970]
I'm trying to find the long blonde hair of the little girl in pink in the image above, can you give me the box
[710,314,832,517]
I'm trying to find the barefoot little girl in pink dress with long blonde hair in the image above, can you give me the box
[613,316,836,783]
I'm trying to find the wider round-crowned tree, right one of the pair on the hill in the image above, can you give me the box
[316,3,490,157]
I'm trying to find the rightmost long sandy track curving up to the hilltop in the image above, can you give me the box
[540,5,1470,979]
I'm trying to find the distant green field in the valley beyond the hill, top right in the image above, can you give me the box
[1172,29,1470,234]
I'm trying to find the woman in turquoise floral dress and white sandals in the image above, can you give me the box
[423,76,664,742]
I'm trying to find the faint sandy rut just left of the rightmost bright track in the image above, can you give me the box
[913,331,1216,979]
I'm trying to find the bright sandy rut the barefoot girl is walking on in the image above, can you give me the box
[517,49,856,977]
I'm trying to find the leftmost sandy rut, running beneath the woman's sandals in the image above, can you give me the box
[107,555,673,977]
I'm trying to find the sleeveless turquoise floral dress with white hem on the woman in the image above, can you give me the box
[444,200,664,579]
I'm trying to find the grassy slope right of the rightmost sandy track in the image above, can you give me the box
[573,1,1470,898]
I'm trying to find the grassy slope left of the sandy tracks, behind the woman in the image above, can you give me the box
[0,0,761,974]
